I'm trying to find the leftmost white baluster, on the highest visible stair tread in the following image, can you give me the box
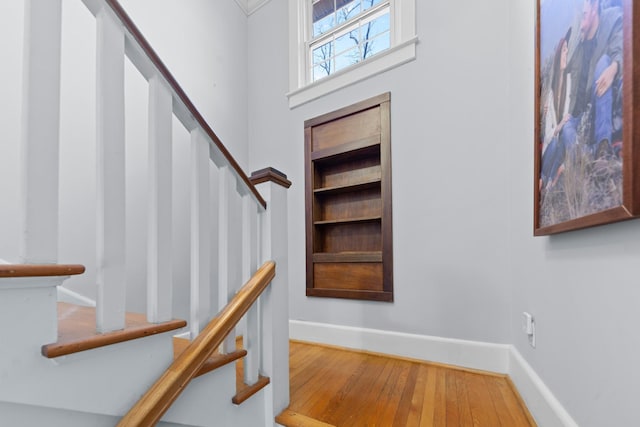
[20,0,62,264]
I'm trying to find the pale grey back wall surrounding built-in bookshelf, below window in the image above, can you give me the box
[249,0,511,343]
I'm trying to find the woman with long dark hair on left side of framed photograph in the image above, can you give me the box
[540,28,571,188]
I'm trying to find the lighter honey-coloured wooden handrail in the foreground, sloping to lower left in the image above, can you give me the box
[118,261,276,427]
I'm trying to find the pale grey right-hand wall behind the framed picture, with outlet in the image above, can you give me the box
[505,2,640,427]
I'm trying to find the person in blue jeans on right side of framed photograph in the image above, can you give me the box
[560,0,623,157]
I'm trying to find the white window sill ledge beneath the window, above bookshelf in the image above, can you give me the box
[287,36,418,108]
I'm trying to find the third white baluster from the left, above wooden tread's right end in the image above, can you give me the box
[147,76,173,323]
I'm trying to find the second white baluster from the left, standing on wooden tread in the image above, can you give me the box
[96,8,126,332]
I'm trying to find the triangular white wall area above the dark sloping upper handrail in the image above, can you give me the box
[121,0,248,170]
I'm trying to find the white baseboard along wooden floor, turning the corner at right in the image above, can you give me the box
[289,320,577,427]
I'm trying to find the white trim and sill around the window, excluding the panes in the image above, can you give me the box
[287,0,418,108]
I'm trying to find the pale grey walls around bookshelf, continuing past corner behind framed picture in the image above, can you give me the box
[249,1,640,427]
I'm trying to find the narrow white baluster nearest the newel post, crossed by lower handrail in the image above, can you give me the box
[242,194,260,384]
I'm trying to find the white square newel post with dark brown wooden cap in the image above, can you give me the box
[251,168,291,420]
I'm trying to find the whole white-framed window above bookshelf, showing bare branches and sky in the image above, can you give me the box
[288,0,417,107]
